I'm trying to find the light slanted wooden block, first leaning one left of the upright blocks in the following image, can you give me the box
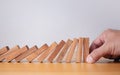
[66,38,78,63]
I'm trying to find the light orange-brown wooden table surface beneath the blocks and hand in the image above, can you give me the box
[0,58,120,75]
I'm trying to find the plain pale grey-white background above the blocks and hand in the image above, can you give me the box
[0,0,120,47]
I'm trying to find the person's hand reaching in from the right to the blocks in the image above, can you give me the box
[86,29,120,63]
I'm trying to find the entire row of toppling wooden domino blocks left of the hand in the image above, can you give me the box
[0,37,89,63]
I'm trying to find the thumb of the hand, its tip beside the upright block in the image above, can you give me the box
[86,44,108,63]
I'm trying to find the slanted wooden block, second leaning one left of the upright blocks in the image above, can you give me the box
[56,39,73,62]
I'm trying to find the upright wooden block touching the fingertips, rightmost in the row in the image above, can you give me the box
[83,38,89,62]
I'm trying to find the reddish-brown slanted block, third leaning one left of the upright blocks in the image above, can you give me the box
[48,40,65,62]
